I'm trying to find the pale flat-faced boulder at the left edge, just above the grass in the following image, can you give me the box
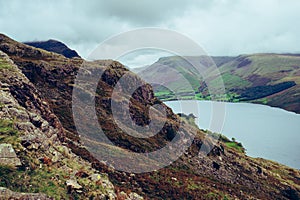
[0,144,21,166]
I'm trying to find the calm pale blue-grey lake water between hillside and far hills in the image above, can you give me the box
[165,101,300,169]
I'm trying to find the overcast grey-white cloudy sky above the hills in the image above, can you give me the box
[0,0,300,65]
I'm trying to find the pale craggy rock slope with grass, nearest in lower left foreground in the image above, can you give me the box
[0,38,136,199]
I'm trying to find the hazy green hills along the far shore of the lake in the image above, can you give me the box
[135,54,300,113]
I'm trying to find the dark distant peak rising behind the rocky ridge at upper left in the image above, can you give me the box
[24,40,80,58]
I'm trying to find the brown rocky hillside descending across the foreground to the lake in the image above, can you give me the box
[0,35,300,199]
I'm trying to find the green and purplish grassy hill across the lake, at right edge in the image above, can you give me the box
[220,54,300,113]
